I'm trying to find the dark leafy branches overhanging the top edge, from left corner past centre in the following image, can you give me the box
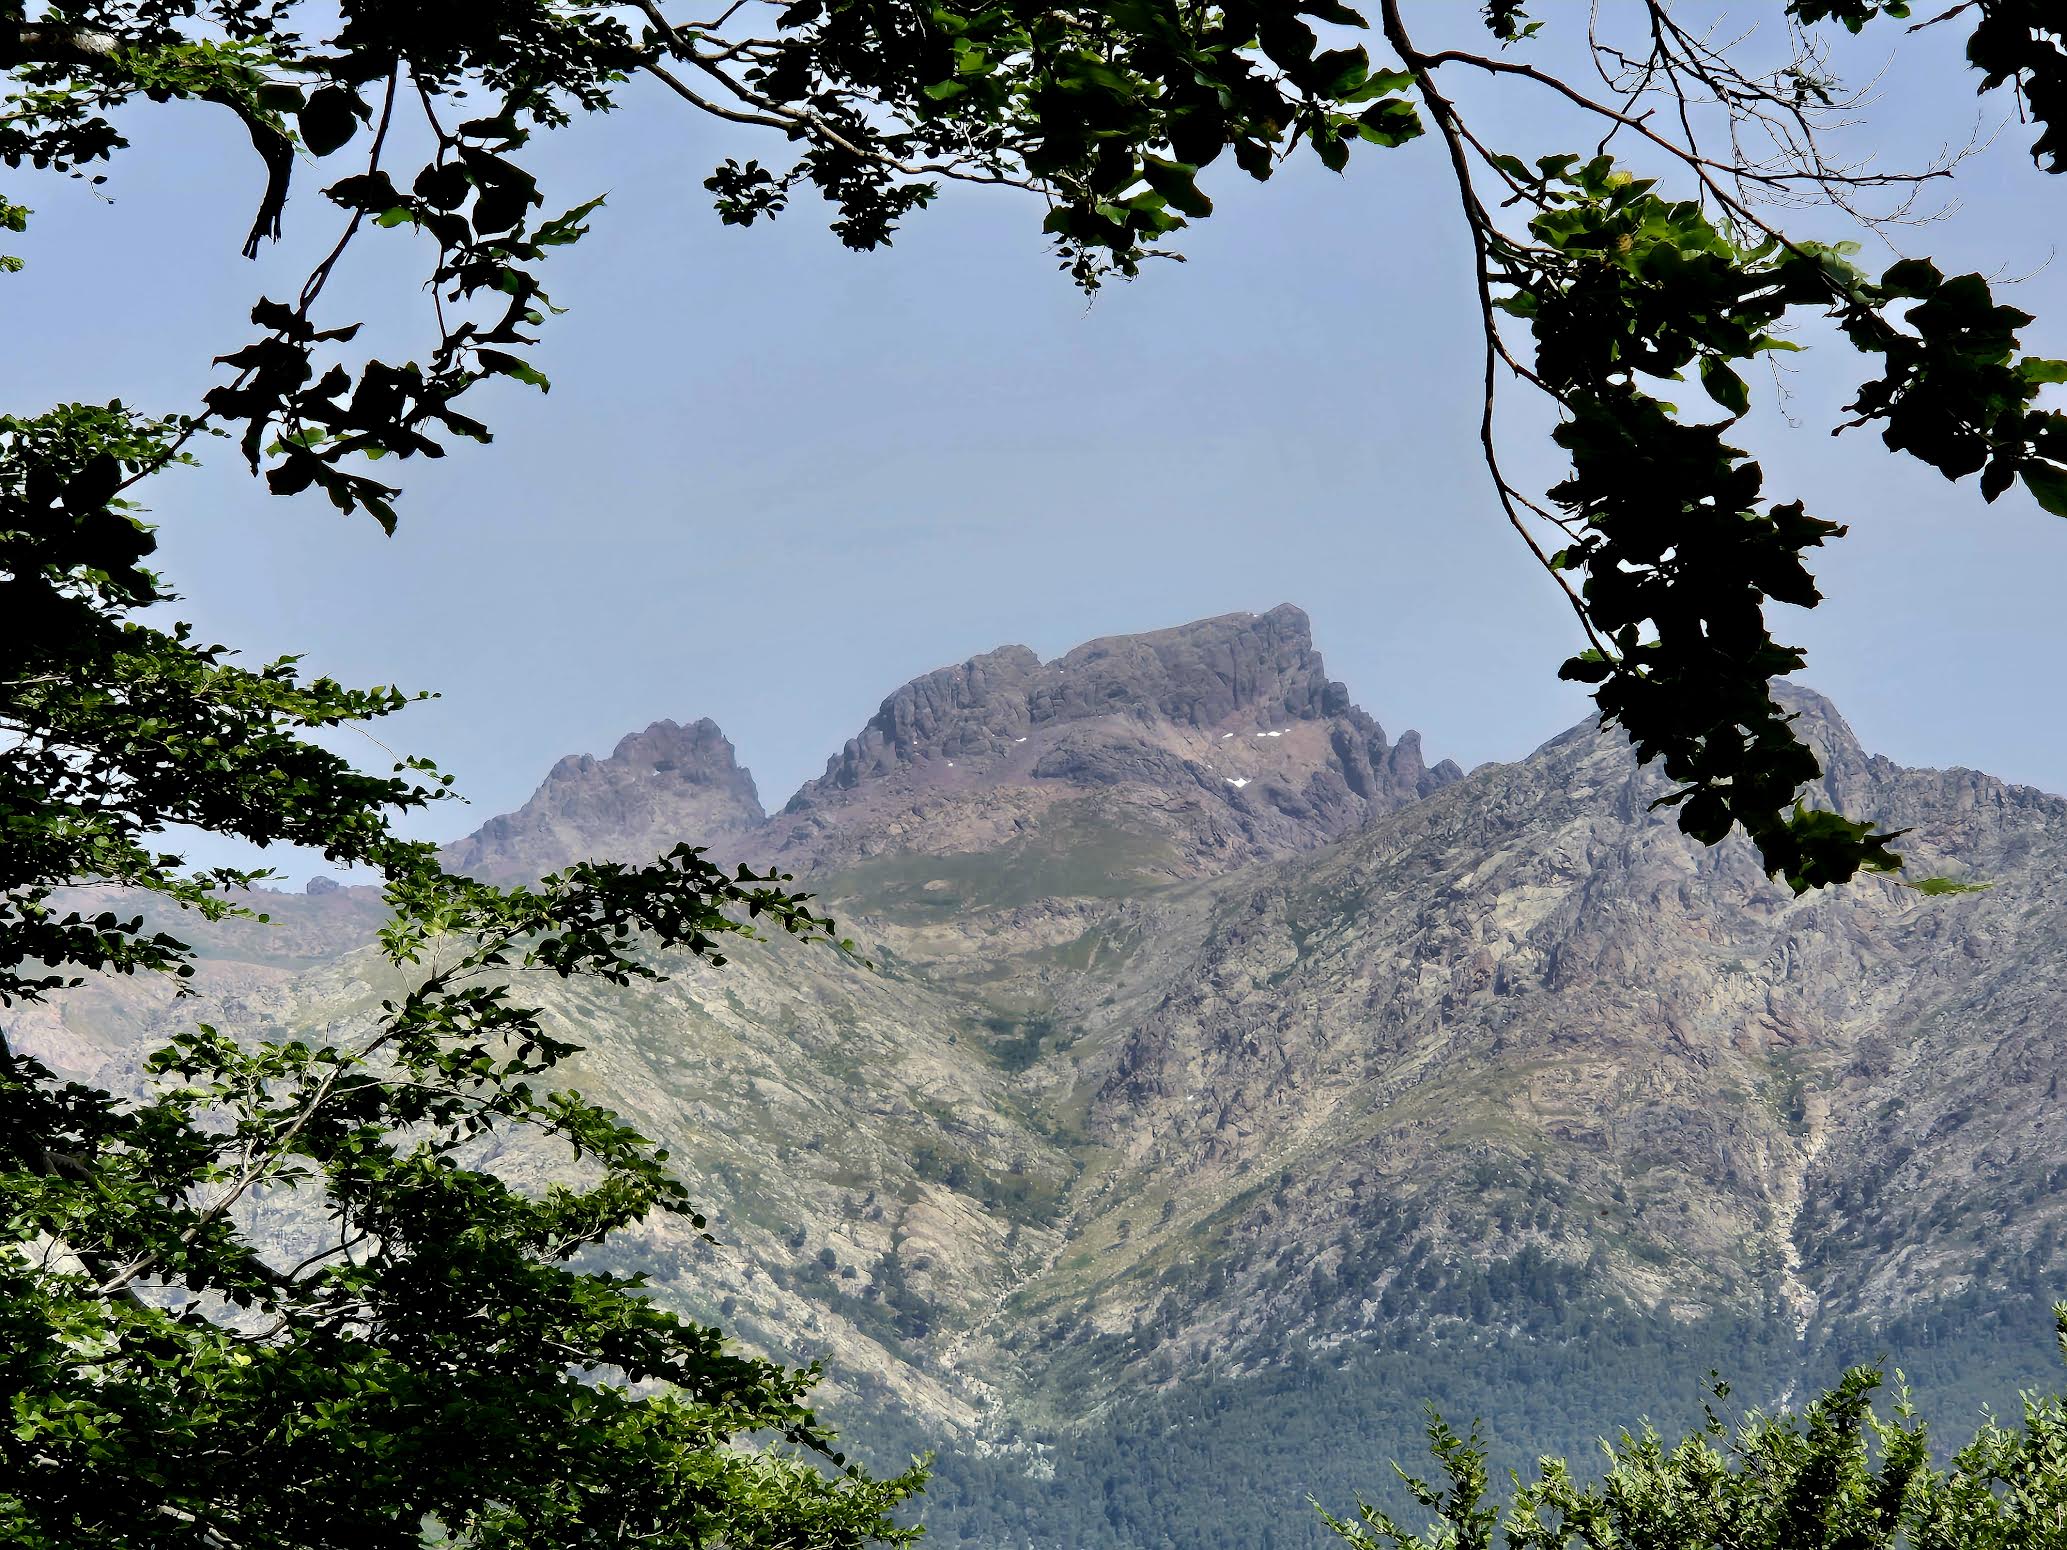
[0,0,1412,527]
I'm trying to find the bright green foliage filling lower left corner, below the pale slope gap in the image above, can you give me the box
[0,847,922,1548]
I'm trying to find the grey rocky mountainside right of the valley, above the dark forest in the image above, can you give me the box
[1033,694,2067,1380]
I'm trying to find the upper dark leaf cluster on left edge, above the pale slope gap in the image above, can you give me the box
[0,403,446,1004]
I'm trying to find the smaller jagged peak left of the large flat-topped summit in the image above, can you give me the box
[442,717,767,880]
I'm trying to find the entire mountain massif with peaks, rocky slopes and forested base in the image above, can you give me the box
[29,608,2067,1546]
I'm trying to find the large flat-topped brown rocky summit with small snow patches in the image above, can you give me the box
[783,603,1459,868]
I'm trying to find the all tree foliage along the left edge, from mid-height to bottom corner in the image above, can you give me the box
[0,405,924,1550]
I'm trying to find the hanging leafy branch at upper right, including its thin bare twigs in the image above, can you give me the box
[1381,0,2067,893]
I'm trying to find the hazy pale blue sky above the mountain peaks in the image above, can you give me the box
[16,0,2067,874]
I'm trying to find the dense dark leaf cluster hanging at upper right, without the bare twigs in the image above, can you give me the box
[1488,155,2067,891]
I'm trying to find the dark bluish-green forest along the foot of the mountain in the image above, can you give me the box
[855,1277,2067,1550]
